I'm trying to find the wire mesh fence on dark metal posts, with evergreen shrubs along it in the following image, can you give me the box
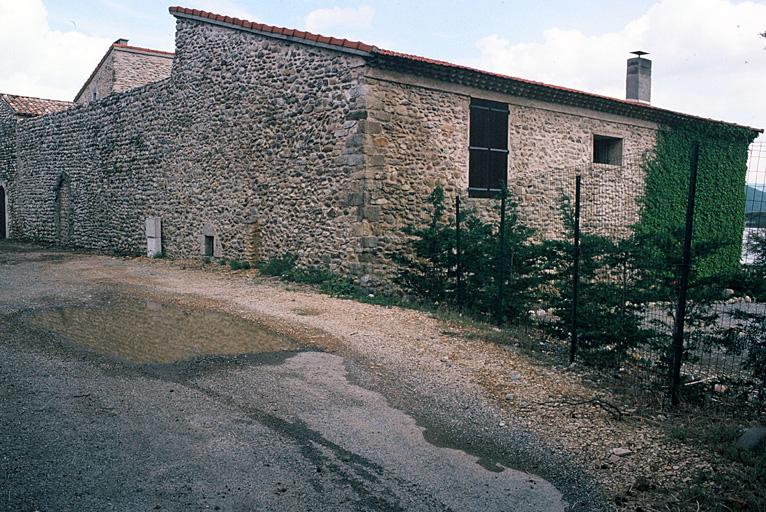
[410,143,766,406]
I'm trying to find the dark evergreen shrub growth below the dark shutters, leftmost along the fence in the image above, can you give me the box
[394,186,540,322]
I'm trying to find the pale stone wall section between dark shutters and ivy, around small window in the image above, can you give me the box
[508,104,656,238]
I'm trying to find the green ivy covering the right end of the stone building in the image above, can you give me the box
[636,124,757,276]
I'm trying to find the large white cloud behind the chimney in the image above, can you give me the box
[468,0,766,134]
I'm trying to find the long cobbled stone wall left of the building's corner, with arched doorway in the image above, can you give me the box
[6,20,372,272]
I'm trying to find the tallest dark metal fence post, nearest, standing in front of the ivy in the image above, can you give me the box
[670,143,700,405]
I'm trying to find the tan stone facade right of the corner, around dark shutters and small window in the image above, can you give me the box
[360,70,657,282]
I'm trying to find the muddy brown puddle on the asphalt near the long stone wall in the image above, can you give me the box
[31,298,305,363]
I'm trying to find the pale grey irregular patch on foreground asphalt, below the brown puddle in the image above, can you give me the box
[218,352,567,512]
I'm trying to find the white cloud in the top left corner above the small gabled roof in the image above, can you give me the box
[0,0,112,100]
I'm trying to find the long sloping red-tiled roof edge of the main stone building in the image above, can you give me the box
[169,7,763,136]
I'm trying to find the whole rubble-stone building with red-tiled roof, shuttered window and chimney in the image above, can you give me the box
[0,7,756,284]
